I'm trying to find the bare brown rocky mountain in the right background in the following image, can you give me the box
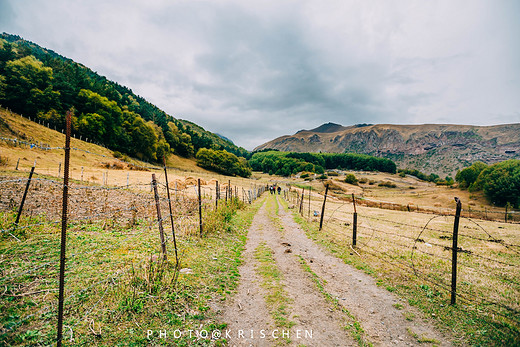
[255,123,520,176]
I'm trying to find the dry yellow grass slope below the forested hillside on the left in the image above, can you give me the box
[0,109,258,195]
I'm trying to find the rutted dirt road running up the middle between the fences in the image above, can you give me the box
[222,195,451,346]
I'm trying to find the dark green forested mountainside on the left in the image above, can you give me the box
[0,33,249,162]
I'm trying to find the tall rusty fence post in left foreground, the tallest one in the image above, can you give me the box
[56,111,72,347]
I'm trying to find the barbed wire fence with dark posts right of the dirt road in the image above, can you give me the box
[283,187,520,338]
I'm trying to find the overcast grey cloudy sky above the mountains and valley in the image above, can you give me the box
[0,0,520,149]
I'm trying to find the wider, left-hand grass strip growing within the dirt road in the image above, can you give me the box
[255,243,294,342]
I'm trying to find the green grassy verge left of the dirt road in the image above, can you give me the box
[0,194,263,346]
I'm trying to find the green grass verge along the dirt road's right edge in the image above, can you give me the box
[284,198,520,346]
